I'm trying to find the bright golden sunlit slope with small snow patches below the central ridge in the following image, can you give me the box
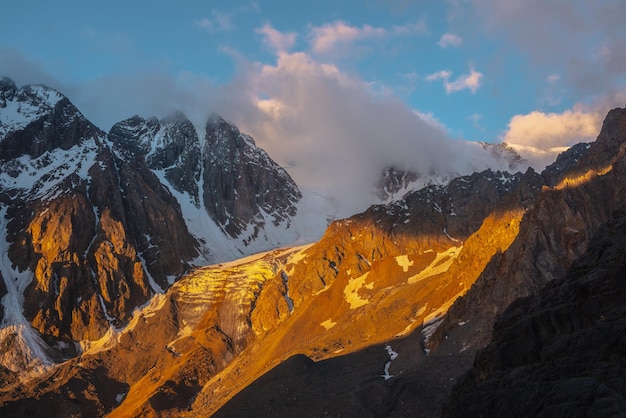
[182,196,524,415]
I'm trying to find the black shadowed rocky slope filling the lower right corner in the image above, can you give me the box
[444,212,626,417]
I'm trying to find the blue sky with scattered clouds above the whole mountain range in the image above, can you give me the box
[0,0,626,212]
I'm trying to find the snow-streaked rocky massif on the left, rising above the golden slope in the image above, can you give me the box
[0,78,300,378]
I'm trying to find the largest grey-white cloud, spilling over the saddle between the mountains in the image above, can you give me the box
[210,52,508,216]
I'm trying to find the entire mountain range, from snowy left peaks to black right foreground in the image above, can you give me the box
[0,78,626,416]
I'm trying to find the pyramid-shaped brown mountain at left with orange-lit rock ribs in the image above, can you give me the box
[2,145,197,348]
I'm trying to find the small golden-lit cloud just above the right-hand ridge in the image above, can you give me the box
[503,107,604,170]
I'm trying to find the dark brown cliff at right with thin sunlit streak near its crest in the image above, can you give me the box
[432,109,626,347]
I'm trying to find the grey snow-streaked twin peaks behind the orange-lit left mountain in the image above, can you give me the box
[109,113,302,250]
